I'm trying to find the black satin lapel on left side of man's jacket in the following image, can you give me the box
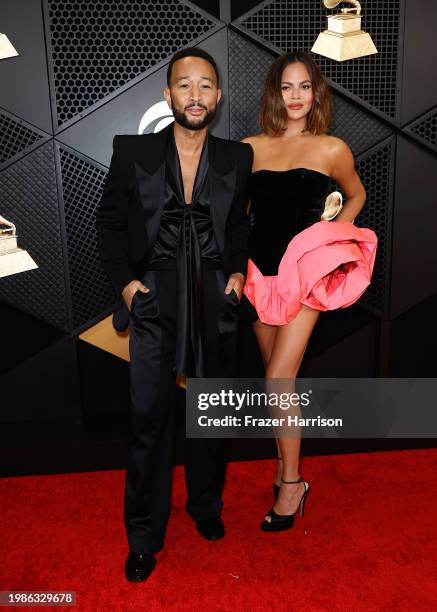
[135,161,165,252]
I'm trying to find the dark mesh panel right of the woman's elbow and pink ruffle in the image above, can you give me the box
[332,136,395,316]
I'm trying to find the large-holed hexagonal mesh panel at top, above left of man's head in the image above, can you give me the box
[48,0,215,124]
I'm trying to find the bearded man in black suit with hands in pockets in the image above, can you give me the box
[96,48,252,581]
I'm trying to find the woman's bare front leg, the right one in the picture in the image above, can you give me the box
[266,305,320,515]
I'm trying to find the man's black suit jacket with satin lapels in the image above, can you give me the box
[96,124,253,296]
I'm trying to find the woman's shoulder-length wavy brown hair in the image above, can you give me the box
[259,51,332,136]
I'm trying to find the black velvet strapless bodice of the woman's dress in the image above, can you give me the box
[241,168,331,322]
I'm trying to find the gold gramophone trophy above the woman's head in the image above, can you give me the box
[311,0,378,62]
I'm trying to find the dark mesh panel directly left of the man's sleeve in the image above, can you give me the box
[60,149,115,328]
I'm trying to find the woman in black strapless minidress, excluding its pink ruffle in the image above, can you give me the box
[243,51,366,531]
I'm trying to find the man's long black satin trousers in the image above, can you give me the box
[124,262,238,553]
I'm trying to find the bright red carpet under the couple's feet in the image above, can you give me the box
[0,450,437,612]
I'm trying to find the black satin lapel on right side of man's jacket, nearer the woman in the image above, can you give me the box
[209,162,237,253]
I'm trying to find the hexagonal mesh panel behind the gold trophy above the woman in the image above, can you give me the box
[235,0,400,117]
